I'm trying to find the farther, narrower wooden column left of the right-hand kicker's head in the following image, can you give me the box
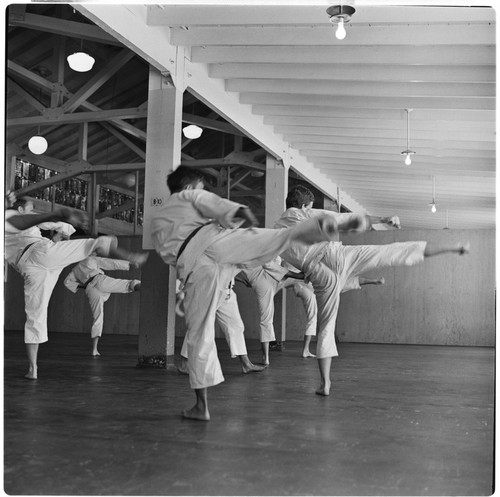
[265,155,288,342]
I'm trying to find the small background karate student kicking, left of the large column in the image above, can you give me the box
[64,256,141,357]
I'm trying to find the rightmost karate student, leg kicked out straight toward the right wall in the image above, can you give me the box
[275,186,470,395]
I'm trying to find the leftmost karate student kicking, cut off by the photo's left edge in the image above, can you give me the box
[5,198,147,380]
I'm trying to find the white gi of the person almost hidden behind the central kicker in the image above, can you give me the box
[181,287,247,359]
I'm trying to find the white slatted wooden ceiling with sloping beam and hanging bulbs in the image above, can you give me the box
[78,1,496,229]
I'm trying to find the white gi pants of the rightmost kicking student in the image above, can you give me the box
[307,242,427,359]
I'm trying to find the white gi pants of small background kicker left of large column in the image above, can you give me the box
[85,274,140,338]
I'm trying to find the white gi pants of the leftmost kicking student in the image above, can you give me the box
[16,236,114,343]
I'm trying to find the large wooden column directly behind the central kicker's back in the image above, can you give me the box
[139,68,182,367]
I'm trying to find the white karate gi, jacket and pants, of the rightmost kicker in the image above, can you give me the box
[275,207,427,359]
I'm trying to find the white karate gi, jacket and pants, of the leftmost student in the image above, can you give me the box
[5,209,114,343]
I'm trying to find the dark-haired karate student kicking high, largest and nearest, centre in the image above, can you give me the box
[151,166,364,421]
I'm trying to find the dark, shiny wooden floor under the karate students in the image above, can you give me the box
[4,332,495,496]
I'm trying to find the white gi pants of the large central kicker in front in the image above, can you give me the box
[177,220,327,389]
